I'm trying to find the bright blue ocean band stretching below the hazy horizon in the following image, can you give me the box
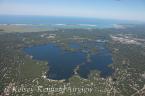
[0,16,140,28]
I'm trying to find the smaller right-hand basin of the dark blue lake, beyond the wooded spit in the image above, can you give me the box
[79,43,113,78]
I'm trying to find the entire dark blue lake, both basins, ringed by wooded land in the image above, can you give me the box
[24,44,113,80]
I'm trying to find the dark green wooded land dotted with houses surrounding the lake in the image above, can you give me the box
[0,26,145,96]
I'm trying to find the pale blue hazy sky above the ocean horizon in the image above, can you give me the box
[0,0,145,21]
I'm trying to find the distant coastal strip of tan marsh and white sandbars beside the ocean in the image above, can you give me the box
[0,24,145,33]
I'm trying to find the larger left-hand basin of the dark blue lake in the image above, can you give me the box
[24,44,85,80]
